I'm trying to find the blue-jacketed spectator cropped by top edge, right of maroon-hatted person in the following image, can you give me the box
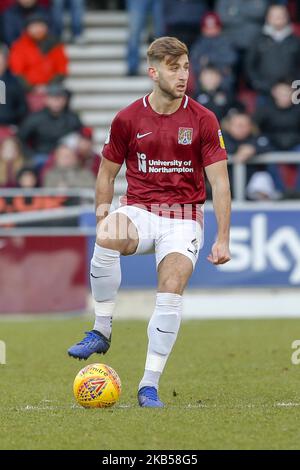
[215,0,269,53]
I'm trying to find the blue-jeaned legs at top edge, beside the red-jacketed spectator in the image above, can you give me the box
[52,0,85,43]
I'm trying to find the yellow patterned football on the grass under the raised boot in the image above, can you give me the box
[73,364,121,408]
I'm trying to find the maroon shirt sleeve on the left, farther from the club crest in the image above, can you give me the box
[102,114,129,165]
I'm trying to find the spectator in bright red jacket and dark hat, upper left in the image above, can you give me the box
[10,14,68,90]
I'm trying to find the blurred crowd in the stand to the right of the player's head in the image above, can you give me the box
[126,0,300,200]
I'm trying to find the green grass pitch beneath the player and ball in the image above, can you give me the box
[0,317,300,450]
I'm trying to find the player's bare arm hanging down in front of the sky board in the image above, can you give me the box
[205,160,231,264]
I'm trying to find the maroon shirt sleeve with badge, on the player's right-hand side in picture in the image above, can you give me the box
[200,113,227,166]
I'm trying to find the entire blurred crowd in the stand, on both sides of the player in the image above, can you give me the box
[0,0,300,200]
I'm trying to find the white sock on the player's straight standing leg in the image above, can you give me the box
[139,293,182,389]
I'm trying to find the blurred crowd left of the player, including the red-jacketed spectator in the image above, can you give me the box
[0,0,100,193]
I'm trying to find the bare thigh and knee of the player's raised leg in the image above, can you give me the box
[96,212,139,255]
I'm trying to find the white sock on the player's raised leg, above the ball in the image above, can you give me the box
[90,244,121,338]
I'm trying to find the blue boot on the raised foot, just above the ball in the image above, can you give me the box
[68,330,110,360]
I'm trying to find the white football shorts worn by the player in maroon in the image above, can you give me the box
[113,206,203,268]
